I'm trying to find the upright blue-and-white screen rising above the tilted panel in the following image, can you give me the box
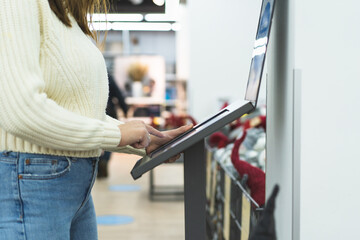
[245,2,273,101]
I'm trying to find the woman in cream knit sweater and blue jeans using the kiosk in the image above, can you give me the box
[0,0,190,240]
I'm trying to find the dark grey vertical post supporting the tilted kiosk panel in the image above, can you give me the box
[184,139,206,240]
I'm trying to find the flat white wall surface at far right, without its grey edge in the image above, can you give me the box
[294,0,360,240]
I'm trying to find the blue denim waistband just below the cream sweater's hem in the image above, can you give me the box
[0,151,98,161]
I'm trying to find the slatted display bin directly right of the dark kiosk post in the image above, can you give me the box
[206,145,264,240]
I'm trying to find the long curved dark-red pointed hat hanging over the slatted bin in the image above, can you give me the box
[231,131,265,206]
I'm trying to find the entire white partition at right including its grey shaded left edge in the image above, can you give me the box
[267,0,360,240]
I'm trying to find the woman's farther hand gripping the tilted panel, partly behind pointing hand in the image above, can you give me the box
[146,124,193,163]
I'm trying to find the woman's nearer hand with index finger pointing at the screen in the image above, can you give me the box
[118,120,166,148]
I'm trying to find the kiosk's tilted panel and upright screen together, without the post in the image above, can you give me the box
[131,0,275,179]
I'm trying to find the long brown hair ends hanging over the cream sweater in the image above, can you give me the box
[48,0,107,40]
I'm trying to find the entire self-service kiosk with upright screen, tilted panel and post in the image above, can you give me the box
[131,0,275,240]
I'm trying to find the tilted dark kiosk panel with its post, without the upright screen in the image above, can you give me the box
[131,100,254,240]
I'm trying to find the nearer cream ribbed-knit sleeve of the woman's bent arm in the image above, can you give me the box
[0,0,121,151]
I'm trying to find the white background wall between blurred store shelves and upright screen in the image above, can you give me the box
[187,0,265,121]
